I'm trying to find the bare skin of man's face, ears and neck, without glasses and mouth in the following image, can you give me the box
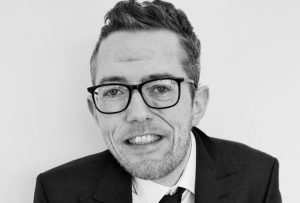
[88,30,208,186]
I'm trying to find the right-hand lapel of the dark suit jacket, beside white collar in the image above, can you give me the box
[193,128,241,203]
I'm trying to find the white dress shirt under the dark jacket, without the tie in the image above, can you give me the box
[132,133,196,203]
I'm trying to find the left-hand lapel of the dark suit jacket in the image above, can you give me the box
[80,153,132,203]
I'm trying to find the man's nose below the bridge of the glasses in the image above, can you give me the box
[126,90,152,122]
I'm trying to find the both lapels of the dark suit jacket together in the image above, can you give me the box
[80,127,241,203]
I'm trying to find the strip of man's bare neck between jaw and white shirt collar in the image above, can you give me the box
[153,142,192,187]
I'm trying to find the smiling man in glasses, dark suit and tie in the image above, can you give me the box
[34,0,281,203]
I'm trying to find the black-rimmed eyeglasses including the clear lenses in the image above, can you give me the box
[87,78,196,114]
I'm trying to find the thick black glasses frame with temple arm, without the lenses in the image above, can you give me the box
[87,77,197,114]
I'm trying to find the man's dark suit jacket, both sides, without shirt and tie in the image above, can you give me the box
[34,128,281,203]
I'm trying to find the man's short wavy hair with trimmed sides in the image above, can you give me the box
[90,0,201,98]
